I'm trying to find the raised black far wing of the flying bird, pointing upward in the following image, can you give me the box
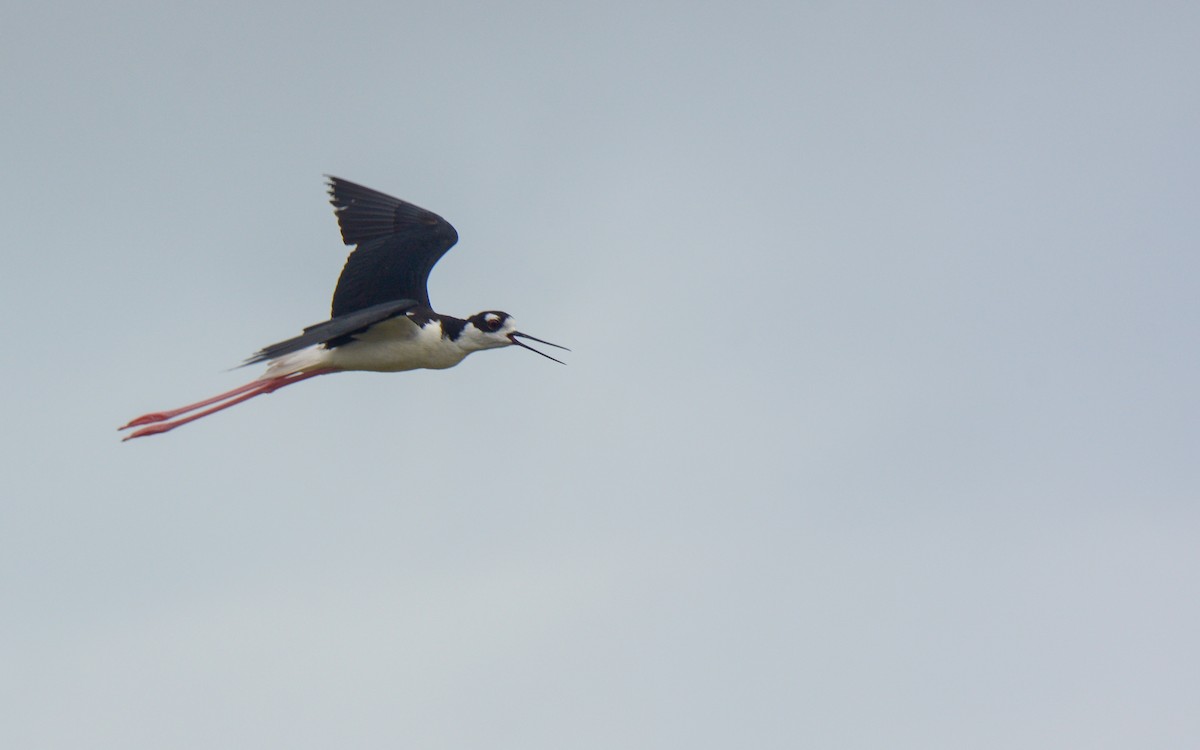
[329,176,458,323]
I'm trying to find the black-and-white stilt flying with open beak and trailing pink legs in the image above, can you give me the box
[119,175,570,440]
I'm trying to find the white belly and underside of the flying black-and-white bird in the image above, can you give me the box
[265,317,470,377]
